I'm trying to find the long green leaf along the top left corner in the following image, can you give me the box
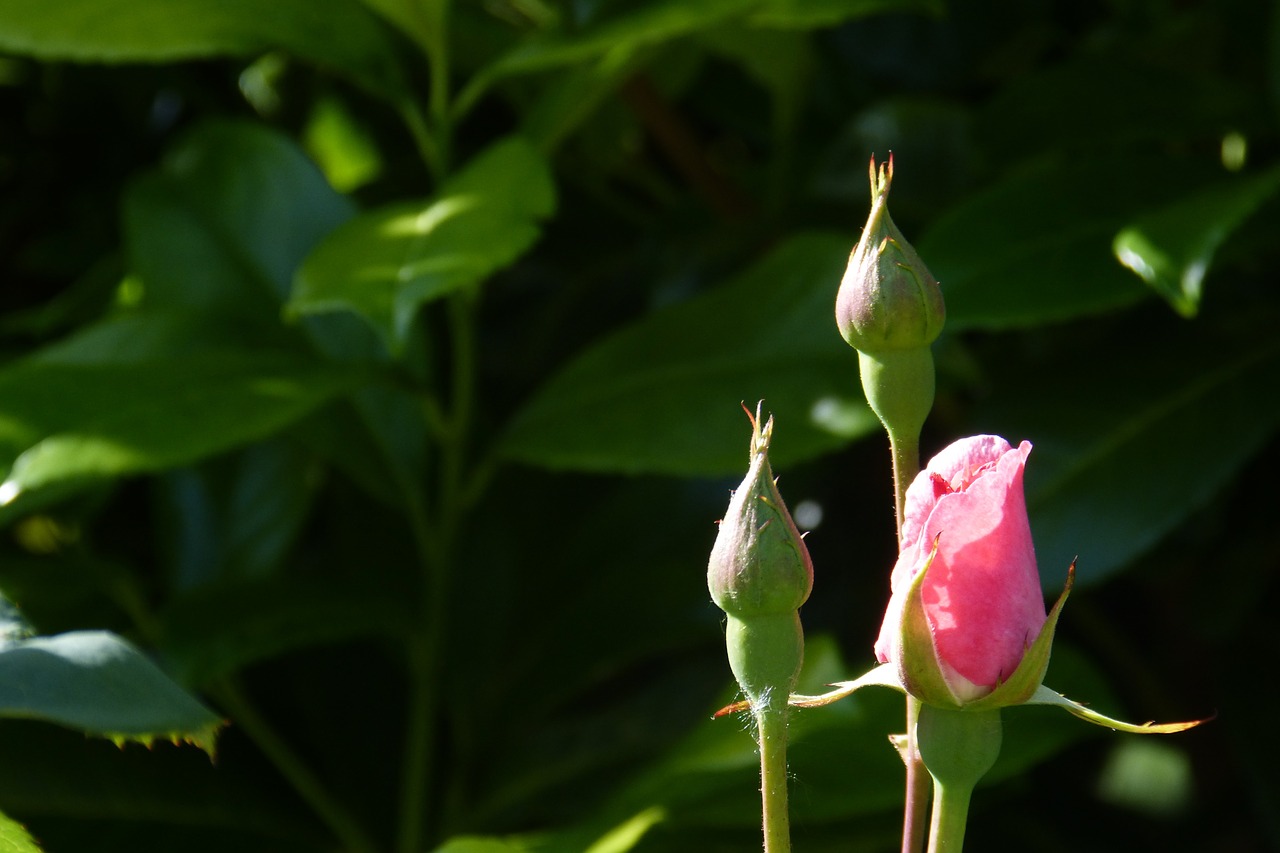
[0,0,407,99]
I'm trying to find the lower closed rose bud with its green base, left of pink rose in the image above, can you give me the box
[707,407,813,706]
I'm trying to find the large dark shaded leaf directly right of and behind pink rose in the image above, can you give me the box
[978,320,1280,590]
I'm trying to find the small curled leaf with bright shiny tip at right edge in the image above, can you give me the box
[1111,168,1280,316]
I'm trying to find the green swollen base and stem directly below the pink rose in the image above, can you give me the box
[918,704,1002,853]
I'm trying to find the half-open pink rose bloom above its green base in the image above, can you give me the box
[876,435,1046,706]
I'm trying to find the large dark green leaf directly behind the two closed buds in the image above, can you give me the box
[502,233,878,475]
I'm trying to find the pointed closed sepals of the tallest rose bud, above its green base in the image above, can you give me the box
[836,155,946,352]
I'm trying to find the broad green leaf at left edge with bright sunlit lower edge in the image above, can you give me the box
[0,312,358,506]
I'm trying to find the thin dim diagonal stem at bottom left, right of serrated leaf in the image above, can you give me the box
[210,679,378,853]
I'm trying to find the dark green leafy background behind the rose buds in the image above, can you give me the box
[0,0,1280,853]
